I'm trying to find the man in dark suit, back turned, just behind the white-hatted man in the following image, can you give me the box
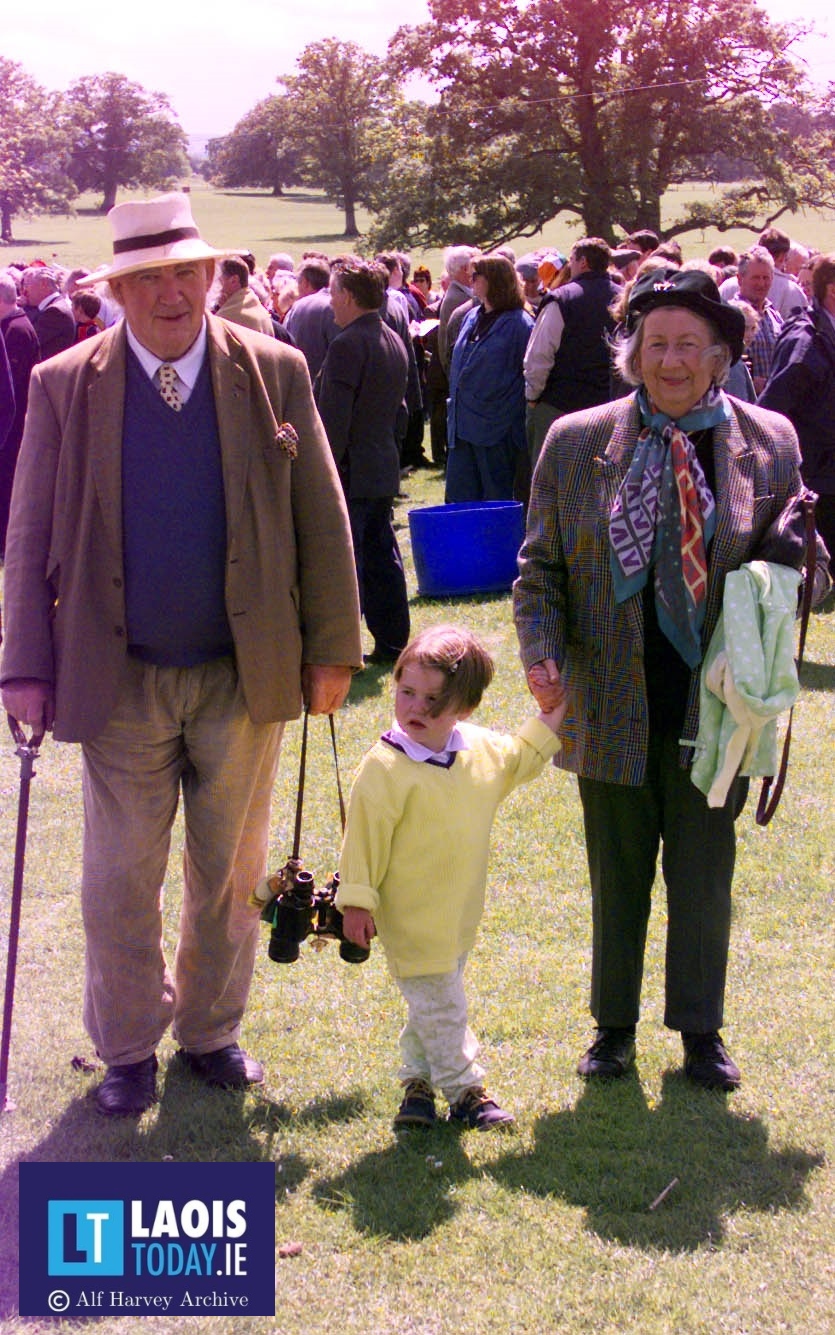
[315,255,409,663]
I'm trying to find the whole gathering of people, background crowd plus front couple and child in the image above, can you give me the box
[0,192,835,1129]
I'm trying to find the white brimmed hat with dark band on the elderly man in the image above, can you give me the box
[77,191,223,287]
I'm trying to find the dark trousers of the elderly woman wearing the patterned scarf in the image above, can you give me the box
[580,734,748,1033]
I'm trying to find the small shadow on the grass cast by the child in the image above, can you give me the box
[313,1123,476,1242]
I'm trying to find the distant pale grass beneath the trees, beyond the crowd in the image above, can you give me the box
[0,178,835,280]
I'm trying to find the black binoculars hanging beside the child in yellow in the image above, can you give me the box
[253,857,371,964]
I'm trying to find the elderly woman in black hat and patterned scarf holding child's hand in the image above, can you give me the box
[514,268,800,1089]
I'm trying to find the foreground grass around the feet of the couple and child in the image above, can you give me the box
[0,453,835,1335]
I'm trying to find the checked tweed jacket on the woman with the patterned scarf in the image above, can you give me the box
[513,394,800,785]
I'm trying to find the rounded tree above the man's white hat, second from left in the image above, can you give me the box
[67,73,188,214]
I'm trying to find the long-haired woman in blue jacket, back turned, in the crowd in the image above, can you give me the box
[446,255,533,503]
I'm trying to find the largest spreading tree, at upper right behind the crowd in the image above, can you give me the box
[374,0,835,246]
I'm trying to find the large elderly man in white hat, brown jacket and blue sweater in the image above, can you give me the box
[0,194,361,1116]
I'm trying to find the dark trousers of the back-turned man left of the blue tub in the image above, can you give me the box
[347,497,409,655]
